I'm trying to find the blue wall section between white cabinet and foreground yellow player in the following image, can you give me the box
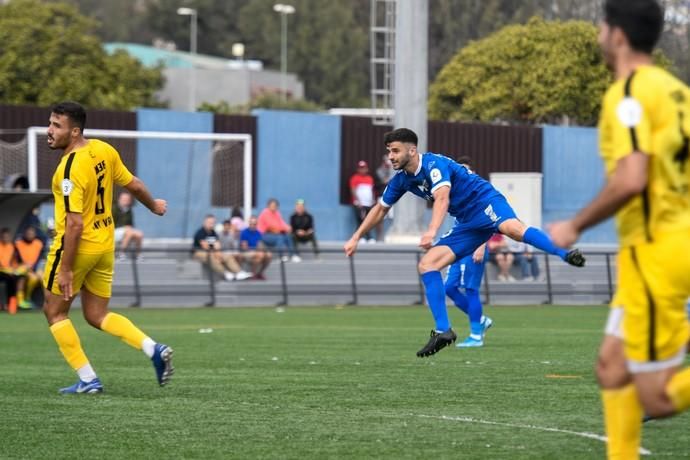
[542,126,618,244]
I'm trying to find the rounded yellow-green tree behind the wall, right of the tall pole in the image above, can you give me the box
[429,17,610,125]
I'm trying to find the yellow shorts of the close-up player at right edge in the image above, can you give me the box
[607,233,690,372]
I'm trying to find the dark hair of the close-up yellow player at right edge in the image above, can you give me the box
[604,0,664,54]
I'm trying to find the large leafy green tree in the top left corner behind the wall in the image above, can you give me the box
[0,0,163,109]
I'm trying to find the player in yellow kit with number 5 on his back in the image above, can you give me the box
[43,102,173,394]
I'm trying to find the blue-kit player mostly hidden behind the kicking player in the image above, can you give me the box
[444,157,493,348]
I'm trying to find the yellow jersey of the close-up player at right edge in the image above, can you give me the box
[599,66,690,247]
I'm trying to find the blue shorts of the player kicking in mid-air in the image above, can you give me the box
[434,196,517,261]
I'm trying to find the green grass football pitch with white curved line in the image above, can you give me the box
[0,306,690,460]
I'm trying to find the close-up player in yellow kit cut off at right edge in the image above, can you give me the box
[550,0,690,459]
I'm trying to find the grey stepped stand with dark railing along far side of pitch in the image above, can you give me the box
[113,244,615,306]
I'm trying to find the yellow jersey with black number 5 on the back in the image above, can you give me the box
[52,139,134,254]
